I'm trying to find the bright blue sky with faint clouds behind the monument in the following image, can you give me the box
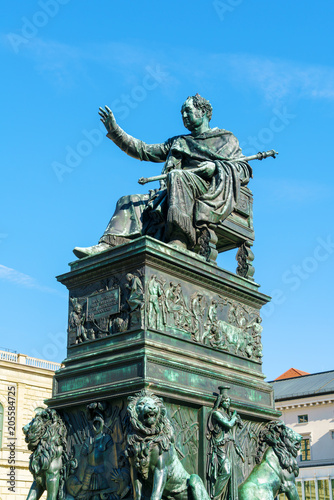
[0,0,334,379]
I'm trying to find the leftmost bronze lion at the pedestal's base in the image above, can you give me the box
[23,408,76,500]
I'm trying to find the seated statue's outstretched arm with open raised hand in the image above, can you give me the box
[99,106,171,163]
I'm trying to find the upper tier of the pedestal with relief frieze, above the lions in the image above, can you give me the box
[50,237,273,412]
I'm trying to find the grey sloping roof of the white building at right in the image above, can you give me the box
[270,370,334,401]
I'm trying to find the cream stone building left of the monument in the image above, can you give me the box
[0,350,60,500]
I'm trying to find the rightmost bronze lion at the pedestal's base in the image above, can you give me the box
[239,420,302,500]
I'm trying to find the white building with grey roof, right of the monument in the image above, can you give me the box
[272,368,334,500]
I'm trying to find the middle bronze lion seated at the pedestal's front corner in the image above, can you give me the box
[126,390,209,500]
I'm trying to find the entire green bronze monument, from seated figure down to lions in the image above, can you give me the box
[23,95,300,500]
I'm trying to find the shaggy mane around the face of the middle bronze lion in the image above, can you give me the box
[126,389,174,479]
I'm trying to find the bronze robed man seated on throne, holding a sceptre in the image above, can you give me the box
[74,94,275,277]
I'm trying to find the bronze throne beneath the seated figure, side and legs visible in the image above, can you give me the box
[197,186,255,280]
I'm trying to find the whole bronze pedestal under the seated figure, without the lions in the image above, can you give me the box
[47,237,279,498]
